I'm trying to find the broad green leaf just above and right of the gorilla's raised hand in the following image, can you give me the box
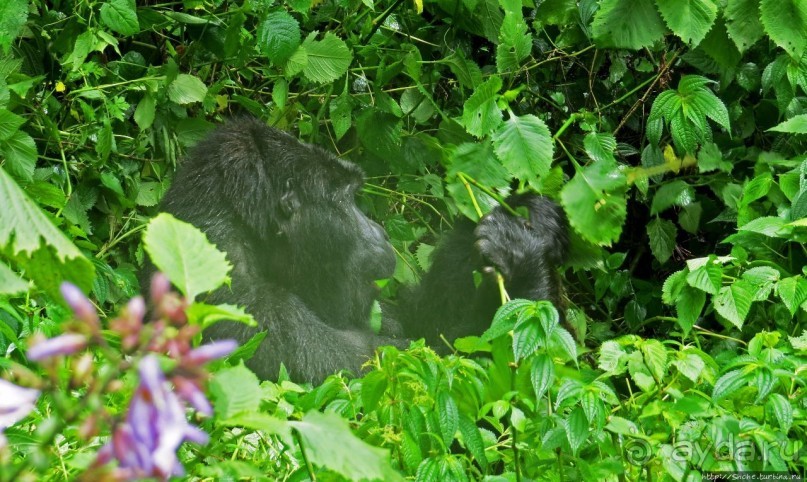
[561,162,627,246]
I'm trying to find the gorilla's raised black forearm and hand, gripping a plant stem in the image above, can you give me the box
[398,195,568,346]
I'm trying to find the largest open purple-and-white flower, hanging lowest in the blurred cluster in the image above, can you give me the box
[99,355,208,479]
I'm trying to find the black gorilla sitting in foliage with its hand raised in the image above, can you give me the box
[162,118,568,382]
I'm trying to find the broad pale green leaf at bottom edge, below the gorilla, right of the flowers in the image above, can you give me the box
[289,411,403,481]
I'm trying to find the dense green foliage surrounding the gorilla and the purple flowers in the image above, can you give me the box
[0,0,807,481]
